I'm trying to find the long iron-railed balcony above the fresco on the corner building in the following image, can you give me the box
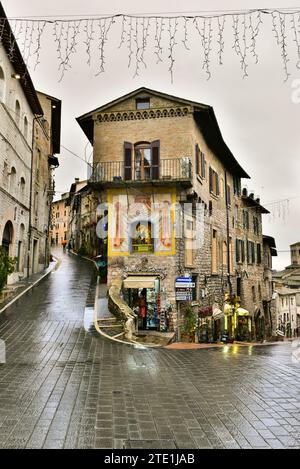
[89,157,192,187]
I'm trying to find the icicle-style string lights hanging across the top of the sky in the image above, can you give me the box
[0,8,300,81]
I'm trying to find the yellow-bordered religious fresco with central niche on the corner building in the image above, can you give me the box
[108,189,176,256]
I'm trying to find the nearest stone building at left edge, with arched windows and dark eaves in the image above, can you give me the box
[0,4,43,283]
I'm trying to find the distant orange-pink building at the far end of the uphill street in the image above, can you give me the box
[50,192,70,246]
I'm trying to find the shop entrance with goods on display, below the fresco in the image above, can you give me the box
[124,276,161,331]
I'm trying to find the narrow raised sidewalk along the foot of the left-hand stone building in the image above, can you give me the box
[0,259,60,314]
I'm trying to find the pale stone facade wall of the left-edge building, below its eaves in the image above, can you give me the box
[0,45,33,283]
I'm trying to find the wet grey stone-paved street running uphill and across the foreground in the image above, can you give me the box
[0,250,300,449]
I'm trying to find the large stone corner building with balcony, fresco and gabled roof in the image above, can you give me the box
[77,88,274,340]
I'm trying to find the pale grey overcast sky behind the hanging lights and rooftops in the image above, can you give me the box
[2,0,300,268]
